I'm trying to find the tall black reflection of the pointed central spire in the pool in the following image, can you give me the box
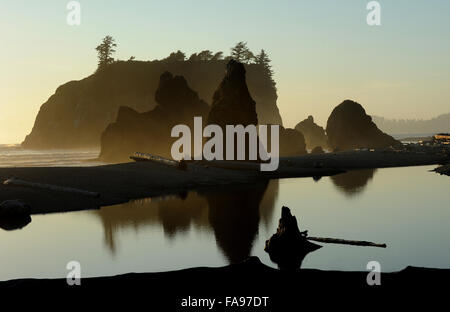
[205,183,267,263]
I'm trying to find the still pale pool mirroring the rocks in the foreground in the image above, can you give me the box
[0,166,450,280]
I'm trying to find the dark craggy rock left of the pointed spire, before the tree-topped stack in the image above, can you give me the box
[100,72,209,161]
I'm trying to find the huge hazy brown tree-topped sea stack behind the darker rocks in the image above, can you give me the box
[22,60,282,149]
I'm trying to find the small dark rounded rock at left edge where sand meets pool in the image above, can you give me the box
[0,199,31,231]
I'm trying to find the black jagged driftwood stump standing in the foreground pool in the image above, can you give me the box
[264,206,322,270]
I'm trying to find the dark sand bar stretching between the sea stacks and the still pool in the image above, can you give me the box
[0,151,449,214]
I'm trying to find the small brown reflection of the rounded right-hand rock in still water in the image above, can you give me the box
[330,169,376,196]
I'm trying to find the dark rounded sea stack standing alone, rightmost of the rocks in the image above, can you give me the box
[327,100,402,150]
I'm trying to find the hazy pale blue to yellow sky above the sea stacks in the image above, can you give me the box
[0,0,450,143]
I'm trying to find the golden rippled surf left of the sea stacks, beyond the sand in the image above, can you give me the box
[0,144,102,168]
